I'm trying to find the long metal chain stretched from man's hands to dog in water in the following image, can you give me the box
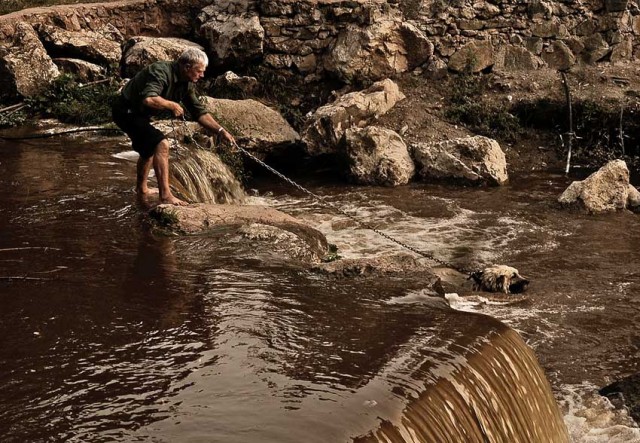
[172,118,474,274]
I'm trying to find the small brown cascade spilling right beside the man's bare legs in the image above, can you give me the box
[170,144,246,204]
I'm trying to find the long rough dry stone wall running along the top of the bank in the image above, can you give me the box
[0,0,640,101]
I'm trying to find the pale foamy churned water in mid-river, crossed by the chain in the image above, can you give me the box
[264,194,555,263]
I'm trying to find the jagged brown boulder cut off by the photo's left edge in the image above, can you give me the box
[0,22,60,100]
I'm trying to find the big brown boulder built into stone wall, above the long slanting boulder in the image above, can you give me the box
[324,17,433,83]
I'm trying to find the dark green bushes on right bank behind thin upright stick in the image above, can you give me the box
[444,73,640,166]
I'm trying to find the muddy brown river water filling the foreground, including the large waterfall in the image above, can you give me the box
[0,129,640,442]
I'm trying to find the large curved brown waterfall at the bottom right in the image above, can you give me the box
[354,326,570,443]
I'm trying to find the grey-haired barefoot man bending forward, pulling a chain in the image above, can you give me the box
[113,48,235,206]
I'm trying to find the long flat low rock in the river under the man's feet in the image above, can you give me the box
[150,204,329,262]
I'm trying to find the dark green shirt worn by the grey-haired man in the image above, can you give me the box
[122,61,207,120]
